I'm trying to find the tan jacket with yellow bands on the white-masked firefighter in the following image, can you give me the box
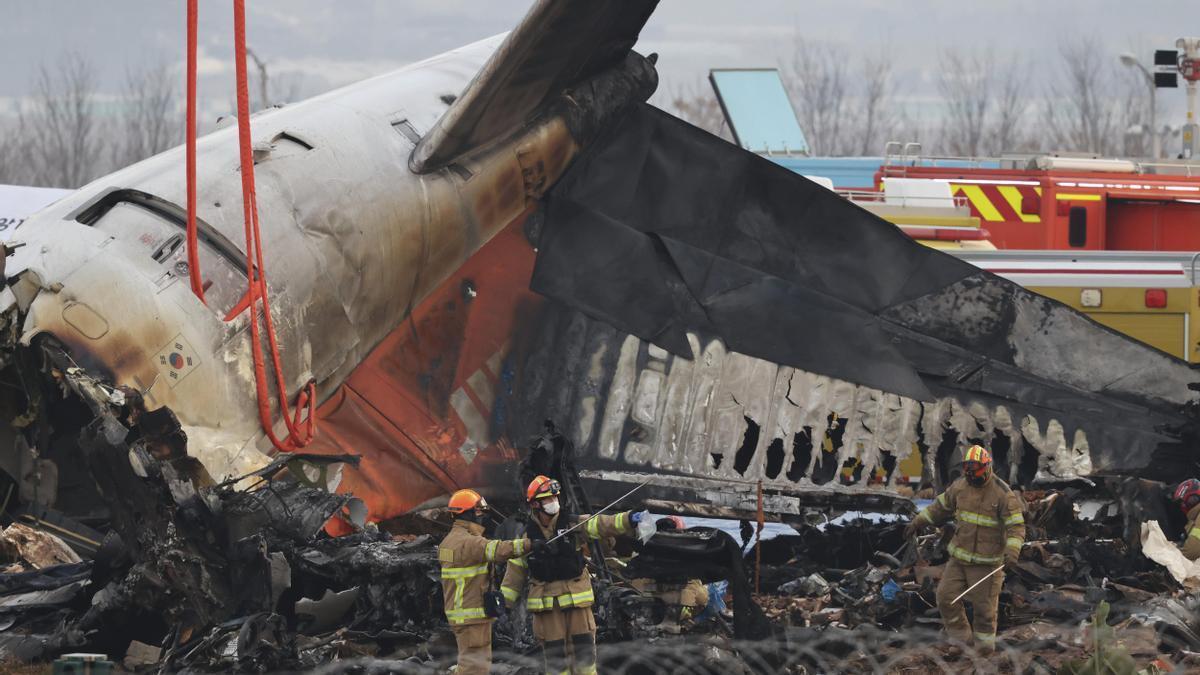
[500,512,634,611]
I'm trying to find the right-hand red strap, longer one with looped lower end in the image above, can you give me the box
[233,0,317,452]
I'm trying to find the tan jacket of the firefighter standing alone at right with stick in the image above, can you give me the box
[917,476,1025,567]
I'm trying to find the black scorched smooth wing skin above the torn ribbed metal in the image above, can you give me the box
[532,104,1194,478]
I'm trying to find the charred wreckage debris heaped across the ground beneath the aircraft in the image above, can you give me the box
[0,382,1200,673]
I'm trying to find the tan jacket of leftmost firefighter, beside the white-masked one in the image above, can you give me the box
[438,520,529,626]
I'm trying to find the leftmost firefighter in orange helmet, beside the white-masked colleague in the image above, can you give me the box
[438,490,529,675]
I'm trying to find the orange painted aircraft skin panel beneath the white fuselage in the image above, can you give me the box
[305,217,541,519]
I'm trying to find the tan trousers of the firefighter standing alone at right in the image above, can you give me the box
[937,557,1004,650]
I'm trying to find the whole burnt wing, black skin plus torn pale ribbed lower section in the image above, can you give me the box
[533,106,1195,480]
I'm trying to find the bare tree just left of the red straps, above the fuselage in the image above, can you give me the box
[113,62,182,167]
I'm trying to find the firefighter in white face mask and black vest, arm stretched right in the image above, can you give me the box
[500,476,646,675]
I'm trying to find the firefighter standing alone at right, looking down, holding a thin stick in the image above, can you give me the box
[905,446,1025,651]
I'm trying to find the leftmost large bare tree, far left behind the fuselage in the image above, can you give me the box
[17,53,104,187]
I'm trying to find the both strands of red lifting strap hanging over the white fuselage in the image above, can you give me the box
[180,0,317,452]
